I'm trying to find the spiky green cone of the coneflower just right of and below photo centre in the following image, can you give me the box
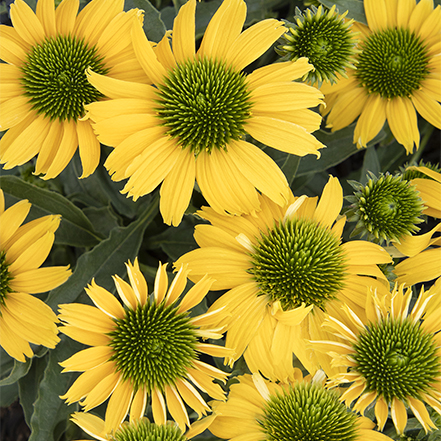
[250,219,346,310]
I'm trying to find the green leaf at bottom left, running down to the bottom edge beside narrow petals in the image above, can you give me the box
[29,337,81,441]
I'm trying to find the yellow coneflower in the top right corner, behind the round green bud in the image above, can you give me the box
[321,0,441,153]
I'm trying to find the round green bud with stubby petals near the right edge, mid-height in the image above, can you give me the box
[348,175,424,242]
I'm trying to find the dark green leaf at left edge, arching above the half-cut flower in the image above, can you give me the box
[0,176,101,247]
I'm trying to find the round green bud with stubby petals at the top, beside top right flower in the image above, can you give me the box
[276,6,356,83]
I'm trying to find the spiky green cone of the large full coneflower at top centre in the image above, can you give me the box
[156,58,252,155]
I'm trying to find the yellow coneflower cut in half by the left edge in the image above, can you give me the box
[0,190,71,362]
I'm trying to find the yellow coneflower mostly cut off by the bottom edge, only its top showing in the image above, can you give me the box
[71,412,212,441]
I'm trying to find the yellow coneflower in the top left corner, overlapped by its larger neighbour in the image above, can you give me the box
[0,0,145,179]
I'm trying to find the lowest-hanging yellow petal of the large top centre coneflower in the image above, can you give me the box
[159,149,196,227]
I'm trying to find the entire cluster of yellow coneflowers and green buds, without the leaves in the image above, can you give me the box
[0,0,441,441]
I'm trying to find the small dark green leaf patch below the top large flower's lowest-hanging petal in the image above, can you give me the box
[148,215,202,261]
